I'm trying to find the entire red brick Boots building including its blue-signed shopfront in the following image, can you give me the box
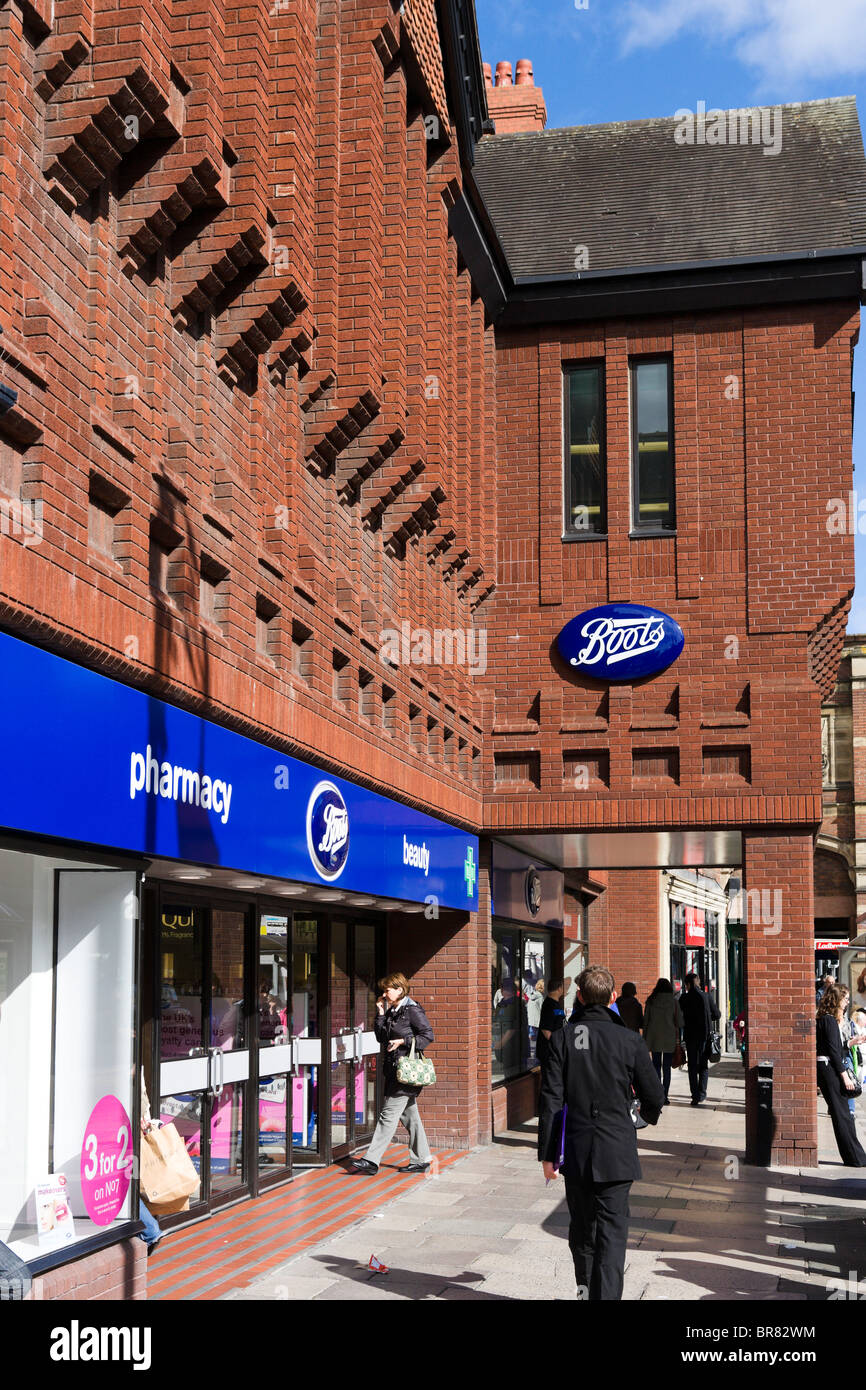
[0,0,863,1297]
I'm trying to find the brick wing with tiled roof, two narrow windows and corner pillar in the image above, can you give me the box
[477,101,863,1163]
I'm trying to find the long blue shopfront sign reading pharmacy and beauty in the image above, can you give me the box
[0,634,478,912]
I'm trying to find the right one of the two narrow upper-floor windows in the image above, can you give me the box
[631,357,677,531]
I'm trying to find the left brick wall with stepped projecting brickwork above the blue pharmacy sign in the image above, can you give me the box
[0,0,495,823]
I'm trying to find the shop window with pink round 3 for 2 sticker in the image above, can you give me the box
[0,851,138,1259]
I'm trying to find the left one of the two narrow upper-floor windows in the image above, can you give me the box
[564,366,607,535]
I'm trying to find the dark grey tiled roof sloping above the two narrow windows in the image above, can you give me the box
[475,97,866,278]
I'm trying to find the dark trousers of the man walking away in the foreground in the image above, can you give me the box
[566,1175,631,1302]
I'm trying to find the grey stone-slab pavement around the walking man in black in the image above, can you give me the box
[225,1061,866,1301]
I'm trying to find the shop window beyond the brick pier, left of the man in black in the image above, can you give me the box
[492,927,552,1081]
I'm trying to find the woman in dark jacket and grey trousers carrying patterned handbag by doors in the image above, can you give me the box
[353,974,434,1176]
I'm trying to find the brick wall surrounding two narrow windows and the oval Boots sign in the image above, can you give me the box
[485,304,858,831]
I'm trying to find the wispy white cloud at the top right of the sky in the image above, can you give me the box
[621,0,866,83]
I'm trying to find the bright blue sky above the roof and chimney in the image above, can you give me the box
[475,0,866,632]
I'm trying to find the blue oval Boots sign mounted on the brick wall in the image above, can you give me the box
[556,603,685,681]
